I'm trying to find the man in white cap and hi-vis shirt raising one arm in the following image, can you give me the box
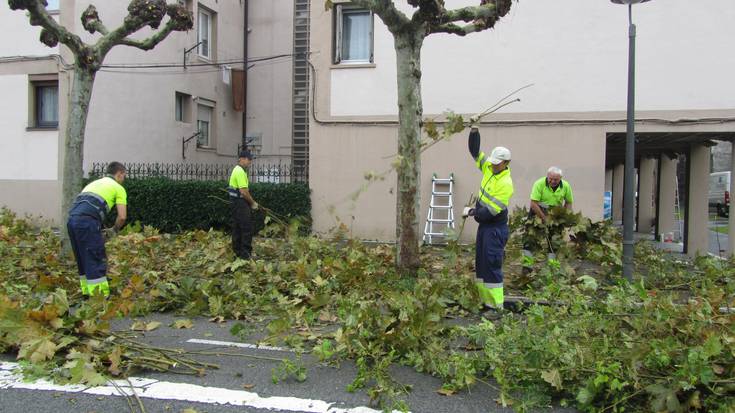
[463,128,513,311]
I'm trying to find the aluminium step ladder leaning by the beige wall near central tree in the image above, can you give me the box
[424,173,454,245]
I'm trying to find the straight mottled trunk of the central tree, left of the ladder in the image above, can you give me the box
[395,30,424,274]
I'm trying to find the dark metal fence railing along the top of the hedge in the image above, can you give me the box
[89,161,307,183]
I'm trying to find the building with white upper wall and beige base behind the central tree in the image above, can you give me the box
[310,0,735,253]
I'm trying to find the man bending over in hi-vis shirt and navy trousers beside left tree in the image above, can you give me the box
[66,162,128,297]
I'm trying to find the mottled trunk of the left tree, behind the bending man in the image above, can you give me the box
[61,66,96,248]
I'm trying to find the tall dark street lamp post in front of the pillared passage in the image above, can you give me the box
[610,0,650,281]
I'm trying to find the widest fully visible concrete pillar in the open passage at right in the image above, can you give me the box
[684,145,710,256]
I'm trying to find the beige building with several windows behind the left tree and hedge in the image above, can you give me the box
[0,0,300,222]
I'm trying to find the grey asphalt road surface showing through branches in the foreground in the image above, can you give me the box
[0,314,574,413]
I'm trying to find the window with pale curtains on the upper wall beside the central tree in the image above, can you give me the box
[334,4,373,63]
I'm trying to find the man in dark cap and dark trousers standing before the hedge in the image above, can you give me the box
[227,150,258,260]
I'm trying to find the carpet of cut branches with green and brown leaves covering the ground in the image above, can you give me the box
[0,211,735,413]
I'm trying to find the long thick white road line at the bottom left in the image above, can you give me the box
[0,362,397,413]
